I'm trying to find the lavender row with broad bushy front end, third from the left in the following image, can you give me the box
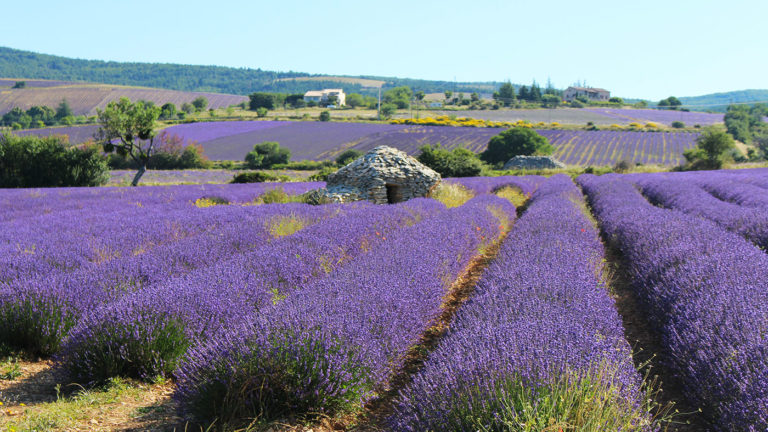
[171,196,514,423]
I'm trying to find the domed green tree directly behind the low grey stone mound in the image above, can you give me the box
[480,127,555,165]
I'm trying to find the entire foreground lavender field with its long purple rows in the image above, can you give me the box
[0,169,768,431]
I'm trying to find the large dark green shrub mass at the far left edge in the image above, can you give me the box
[0,134,109,187]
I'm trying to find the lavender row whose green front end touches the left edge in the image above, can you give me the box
[0,204,333,355]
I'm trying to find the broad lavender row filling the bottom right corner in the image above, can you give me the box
[578,175,768,431]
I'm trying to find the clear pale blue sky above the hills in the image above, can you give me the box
[0,0,768,100]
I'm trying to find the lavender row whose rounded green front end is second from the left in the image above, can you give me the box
[59,200,444,382]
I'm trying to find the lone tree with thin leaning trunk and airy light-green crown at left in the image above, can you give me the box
[95,97,160,186]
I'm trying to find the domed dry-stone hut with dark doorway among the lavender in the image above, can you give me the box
[323,146,440,204]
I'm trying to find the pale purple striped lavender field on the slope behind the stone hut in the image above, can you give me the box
[13,121,698,166]
